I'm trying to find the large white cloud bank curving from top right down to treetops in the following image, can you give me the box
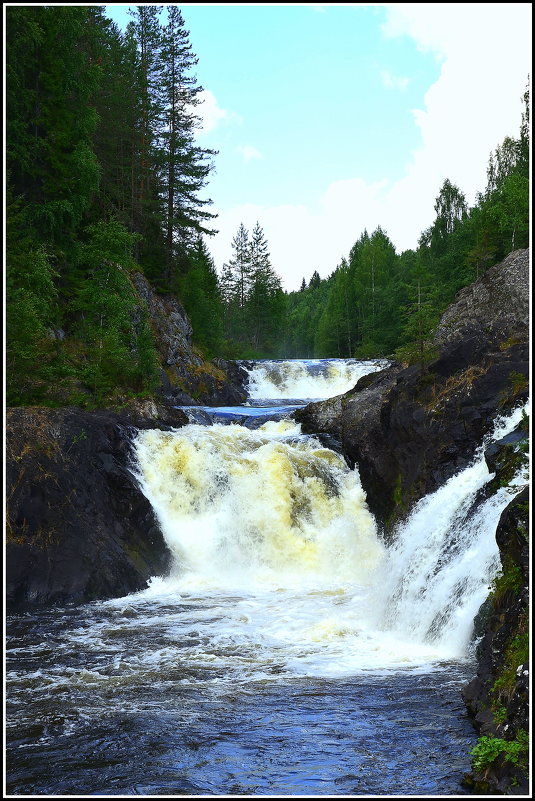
[208,3,531,289]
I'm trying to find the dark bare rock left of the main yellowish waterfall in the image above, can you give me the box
[6,408,185,609]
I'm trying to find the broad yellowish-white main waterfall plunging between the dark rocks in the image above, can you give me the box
[137,421,384,587]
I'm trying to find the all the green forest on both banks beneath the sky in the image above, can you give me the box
[6,5,529,405]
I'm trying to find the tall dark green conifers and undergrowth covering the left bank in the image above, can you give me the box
[6,6,222,404]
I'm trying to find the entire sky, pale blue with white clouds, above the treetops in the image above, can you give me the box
[106,3,531,289]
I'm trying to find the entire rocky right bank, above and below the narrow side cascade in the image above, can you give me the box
[295,250,529,795]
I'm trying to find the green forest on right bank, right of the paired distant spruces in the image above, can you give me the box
[279,91,529,361]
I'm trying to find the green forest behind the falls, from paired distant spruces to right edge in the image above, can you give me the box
[186,79,529,363]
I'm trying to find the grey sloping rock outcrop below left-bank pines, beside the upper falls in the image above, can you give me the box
[132,273,246,406]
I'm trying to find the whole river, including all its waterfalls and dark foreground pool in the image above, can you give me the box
[6,360,523,796]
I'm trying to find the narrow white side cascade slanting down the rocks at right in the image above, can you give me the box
[383,400,528,657]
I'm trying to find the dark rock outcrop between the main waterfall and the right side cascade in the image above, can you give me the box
[295,250,529,532]
